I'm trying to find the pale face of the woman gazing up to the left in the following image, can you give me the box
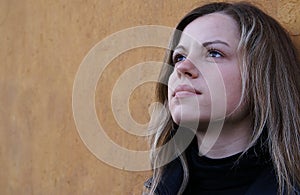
[168,13,248,124]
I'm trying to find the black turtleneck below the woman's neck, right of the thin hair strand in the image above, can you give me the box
[184,139,276,195]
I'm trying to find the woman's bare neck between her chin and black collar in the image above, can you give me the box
[196,117,253,159]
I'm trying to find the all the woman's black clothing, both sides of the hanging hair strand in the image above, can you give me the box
[146,140,278,195]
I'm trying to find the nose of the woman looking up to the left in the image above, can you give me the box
[175,59,199,78]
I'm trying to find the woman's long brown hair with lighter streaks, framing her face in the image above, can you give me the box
[150,3,300,194]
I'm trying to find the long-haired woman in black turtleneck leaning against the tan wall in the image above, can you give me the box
[145,3,300,194]
